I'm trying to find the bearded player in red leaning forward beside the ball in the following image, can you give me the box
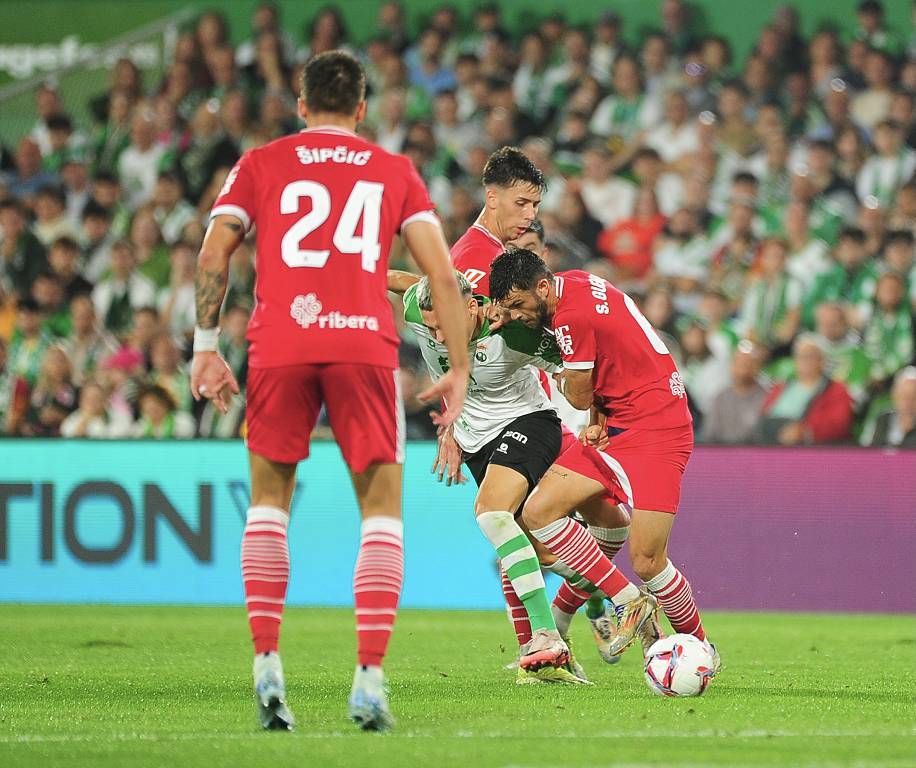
[490,250,719,670]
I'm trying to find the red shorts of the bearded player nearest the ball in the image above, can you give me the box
[556,424,693,514]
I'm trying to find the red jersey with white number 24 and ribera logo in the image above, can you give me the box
[211,127,438,368]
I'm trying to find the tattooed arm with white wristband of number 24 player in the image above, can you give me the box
[191,215,245,413]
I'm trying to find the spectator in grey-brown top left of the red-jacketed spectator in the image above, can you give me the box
[700,341,767,443]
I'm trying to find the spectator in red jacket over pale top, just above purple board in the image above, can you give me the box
[758,334,853,445]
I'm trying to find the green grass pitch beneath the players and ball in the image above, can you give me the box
[0,605,916,768]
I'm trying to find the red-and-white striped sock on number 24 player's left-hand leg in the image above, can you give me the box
[242,506,289,653]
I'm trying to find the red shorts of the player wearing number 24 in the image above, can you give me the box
[246,363,404,472]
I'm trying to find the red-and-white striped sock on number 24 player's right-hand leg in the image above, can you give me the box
[353,516,404,666]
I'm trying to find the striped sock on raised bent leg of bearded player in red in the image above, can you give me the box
[531,517,639,604]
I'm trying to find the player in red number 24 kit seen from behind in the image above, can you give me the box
[191,51,469,730]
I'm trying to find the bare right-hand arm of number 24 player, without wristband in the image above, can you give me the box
[402,220,471,425]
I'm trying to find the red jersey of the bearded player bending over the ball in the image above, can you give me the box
[553,270,692,429]
